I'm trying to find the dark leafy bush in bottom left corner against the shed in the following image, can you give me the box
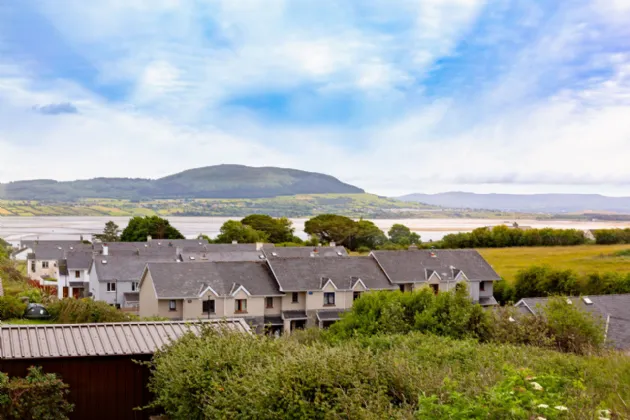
[0,366,73,420]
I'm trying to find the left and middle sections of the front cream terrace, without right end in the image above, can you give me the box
[139,257,397,333]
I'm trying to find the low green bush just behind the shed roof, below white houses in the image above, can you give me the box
[46,298,135,324]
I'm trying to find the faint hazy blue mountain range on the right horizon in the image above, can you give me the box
[398,192,630,213]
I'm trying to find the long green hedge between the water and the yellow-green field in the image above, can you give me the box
[436,225,589,248]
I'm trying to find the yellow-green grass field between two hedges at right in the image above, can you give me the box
[479,245,630,281]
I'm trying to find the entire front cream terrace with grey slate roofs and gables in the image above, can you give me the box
[139,247,499,333]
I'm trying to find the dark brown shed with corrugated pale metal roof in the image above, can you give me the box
[0,319,250,420]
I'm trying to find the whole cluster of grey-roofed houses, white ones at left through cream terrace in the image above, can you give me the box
[14,240,500,333]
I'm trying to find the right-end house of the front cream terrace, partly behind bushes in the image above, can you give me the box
[370,249,501,306]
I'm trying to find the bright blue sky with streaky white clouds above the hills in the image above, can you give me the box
[0,0,630,196]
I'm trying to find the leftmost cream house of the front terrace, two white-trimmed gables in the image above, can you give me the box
[140,261,283,332]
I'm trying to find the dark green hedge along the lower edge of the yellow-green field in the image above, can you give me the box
[493,265,630,303]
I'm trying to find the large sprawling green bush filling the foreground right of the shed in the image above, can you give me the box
[149,328,630,420]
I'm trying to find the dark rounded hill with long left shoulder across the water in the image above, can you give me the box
[0,165,364,202]
